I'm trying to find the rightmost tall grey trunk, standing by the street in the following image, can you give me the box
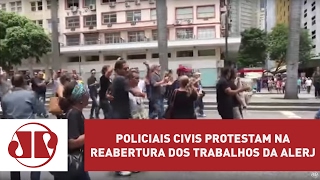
[284,0,302,99]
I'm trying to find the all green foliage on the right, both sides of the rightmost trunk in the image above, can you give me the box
[238,24,313,66]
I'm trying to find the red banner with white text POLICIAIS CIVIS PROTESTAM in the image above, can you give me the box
[84,120,320,171]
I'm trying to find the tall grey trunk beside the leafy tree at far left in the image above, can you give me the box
[51,0,61,71]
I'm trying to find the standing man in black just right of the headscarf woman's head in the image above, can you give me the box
[87,69,100,119]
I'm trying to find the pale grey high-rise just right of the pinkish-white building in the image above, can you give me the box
[230,0,260,37]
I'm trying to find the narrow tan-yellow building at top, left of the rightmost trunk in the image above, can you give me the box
[276,0,290,24]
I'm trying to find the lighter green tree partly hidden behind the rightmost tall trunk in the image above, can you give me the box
[267,24,312,72]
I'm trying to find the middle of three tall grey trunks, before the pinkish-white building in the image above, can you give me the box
[156,0,168,76]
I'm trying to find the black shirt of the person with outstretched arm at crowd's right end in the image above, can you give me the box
[216,78,233,110]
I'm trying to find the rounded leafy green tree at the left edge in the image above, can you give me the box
[0,11,51,69]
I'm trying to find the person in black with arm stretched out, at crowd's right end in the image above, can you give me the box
[216,68,250,119]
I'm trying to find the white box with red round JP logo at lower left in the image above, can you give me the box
[0,119,68,171]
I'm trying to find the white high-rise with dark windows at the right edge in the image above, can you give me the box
[301,0,320,56]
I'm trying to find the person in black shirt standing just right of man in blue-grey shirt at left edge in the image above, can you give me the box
[31,71,49,118]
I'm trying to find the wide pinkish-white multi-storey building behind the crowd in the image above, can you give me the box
[0,0,240,86]
